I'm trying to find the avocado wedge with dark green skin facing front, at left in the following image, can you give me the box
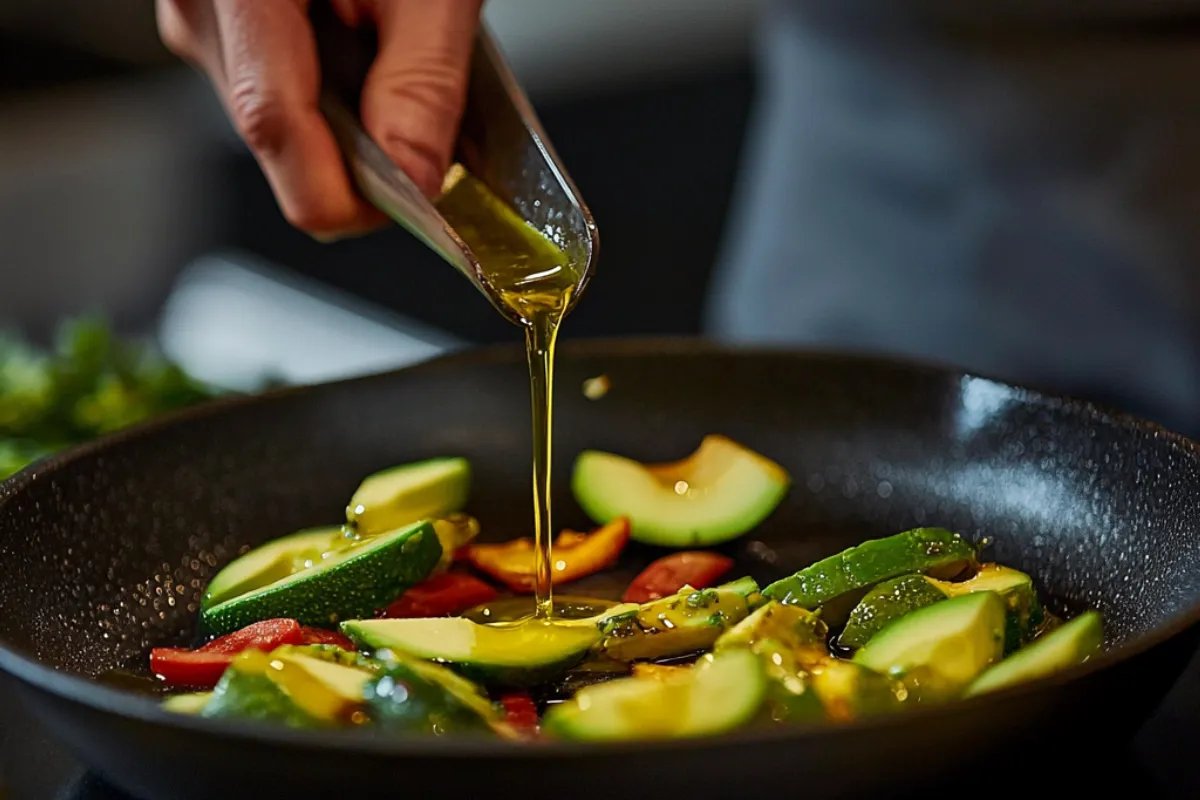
[200,522,442,636]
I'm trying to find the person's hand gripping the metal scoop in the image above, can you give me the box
[156,0,484,239]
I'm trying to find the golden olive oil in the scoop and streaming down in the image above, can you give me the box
[436,164,584,620]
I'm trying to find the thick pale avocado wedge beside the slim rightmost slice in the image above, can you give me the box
[854,591,1006,699]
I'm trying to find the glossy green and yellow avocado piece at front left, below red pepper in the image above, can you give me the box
[200,650,371,728]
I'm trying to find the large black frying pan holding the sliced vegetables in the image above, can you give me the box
[0,342,1200,799]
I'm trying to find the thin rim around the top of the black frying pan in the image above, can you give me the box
[0,337,1200,759]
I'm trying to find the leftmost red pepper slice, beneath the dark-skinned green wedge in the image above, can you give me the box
[150,619,304,688]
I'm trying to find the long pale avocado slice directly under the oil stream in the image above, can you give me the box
[342,616,601,687]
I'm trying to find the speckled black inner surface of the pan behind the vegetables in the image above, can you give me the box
[0,344,1200,676]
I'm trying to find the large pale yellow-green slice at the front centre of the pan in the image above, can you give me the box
[542,650,767,741]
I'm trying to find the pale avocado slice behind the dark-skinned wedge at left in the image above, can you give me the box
[202,527,348,609]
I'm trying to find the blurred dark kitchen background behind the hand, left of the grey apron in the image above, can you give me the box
[0,0,760,386]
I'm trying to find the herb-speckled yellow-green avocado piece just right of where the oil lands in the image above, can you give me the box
[600,578,758,662]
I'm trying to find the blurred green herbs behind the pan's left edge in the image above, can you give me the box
[0,317,217,479]
